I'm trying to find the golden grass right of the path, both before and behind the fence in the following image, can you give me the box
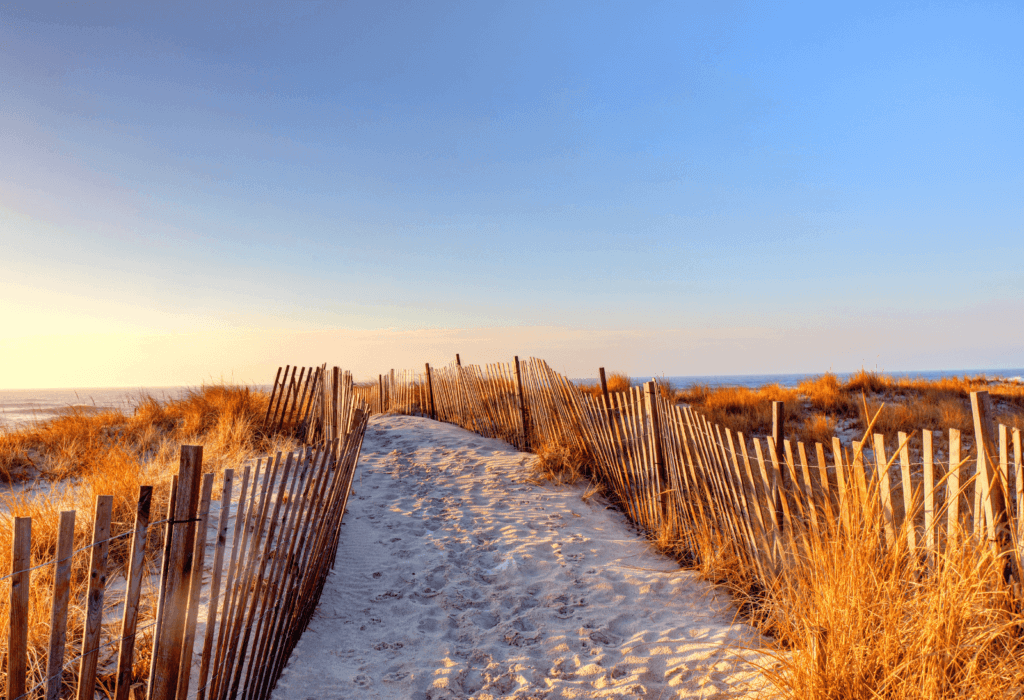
[561,371,1024,700]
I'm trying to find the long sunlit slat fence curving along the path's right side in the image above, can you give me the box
[364,358,1024,585]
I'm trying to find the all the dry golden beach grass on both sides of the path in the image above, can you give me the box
[0,371,1024,700]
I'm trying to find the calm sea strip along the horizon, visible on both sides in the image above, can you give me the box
[0,368,1024,431]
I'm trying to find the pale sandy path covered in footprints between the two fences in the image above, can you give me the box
[273,417,760,700]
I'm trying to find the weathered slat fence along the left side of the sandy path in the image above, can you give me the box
[2,367,369,700]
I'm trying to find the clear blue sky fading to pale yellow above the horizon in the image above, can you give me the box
[0,0,1024,389]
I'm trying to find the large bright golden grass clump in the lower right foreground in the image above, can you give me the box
[754,526,1024,700]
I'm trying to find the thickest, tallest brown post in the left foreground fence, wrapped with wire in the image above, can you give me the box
[150,445,203,700]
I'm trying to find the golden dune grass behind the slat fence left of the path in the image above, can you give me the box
[0,385,284,694]
